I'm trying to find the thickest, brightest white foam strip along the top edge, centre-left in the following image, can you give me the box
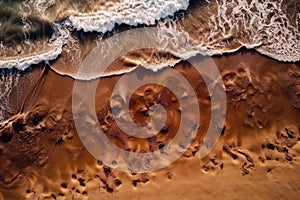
[69,0,189,33]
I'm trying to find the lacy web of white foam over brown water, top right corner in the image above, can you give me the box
[210,0,300,62]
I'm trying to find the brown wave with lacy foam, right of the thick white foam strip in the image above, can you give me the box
[161,0,300,62]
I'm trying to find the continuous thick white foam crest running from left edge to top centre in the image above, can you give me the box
[0,0,189,70]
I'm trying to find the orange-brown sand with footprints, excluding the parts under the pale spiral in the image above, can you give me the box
[0,50,300,200]
